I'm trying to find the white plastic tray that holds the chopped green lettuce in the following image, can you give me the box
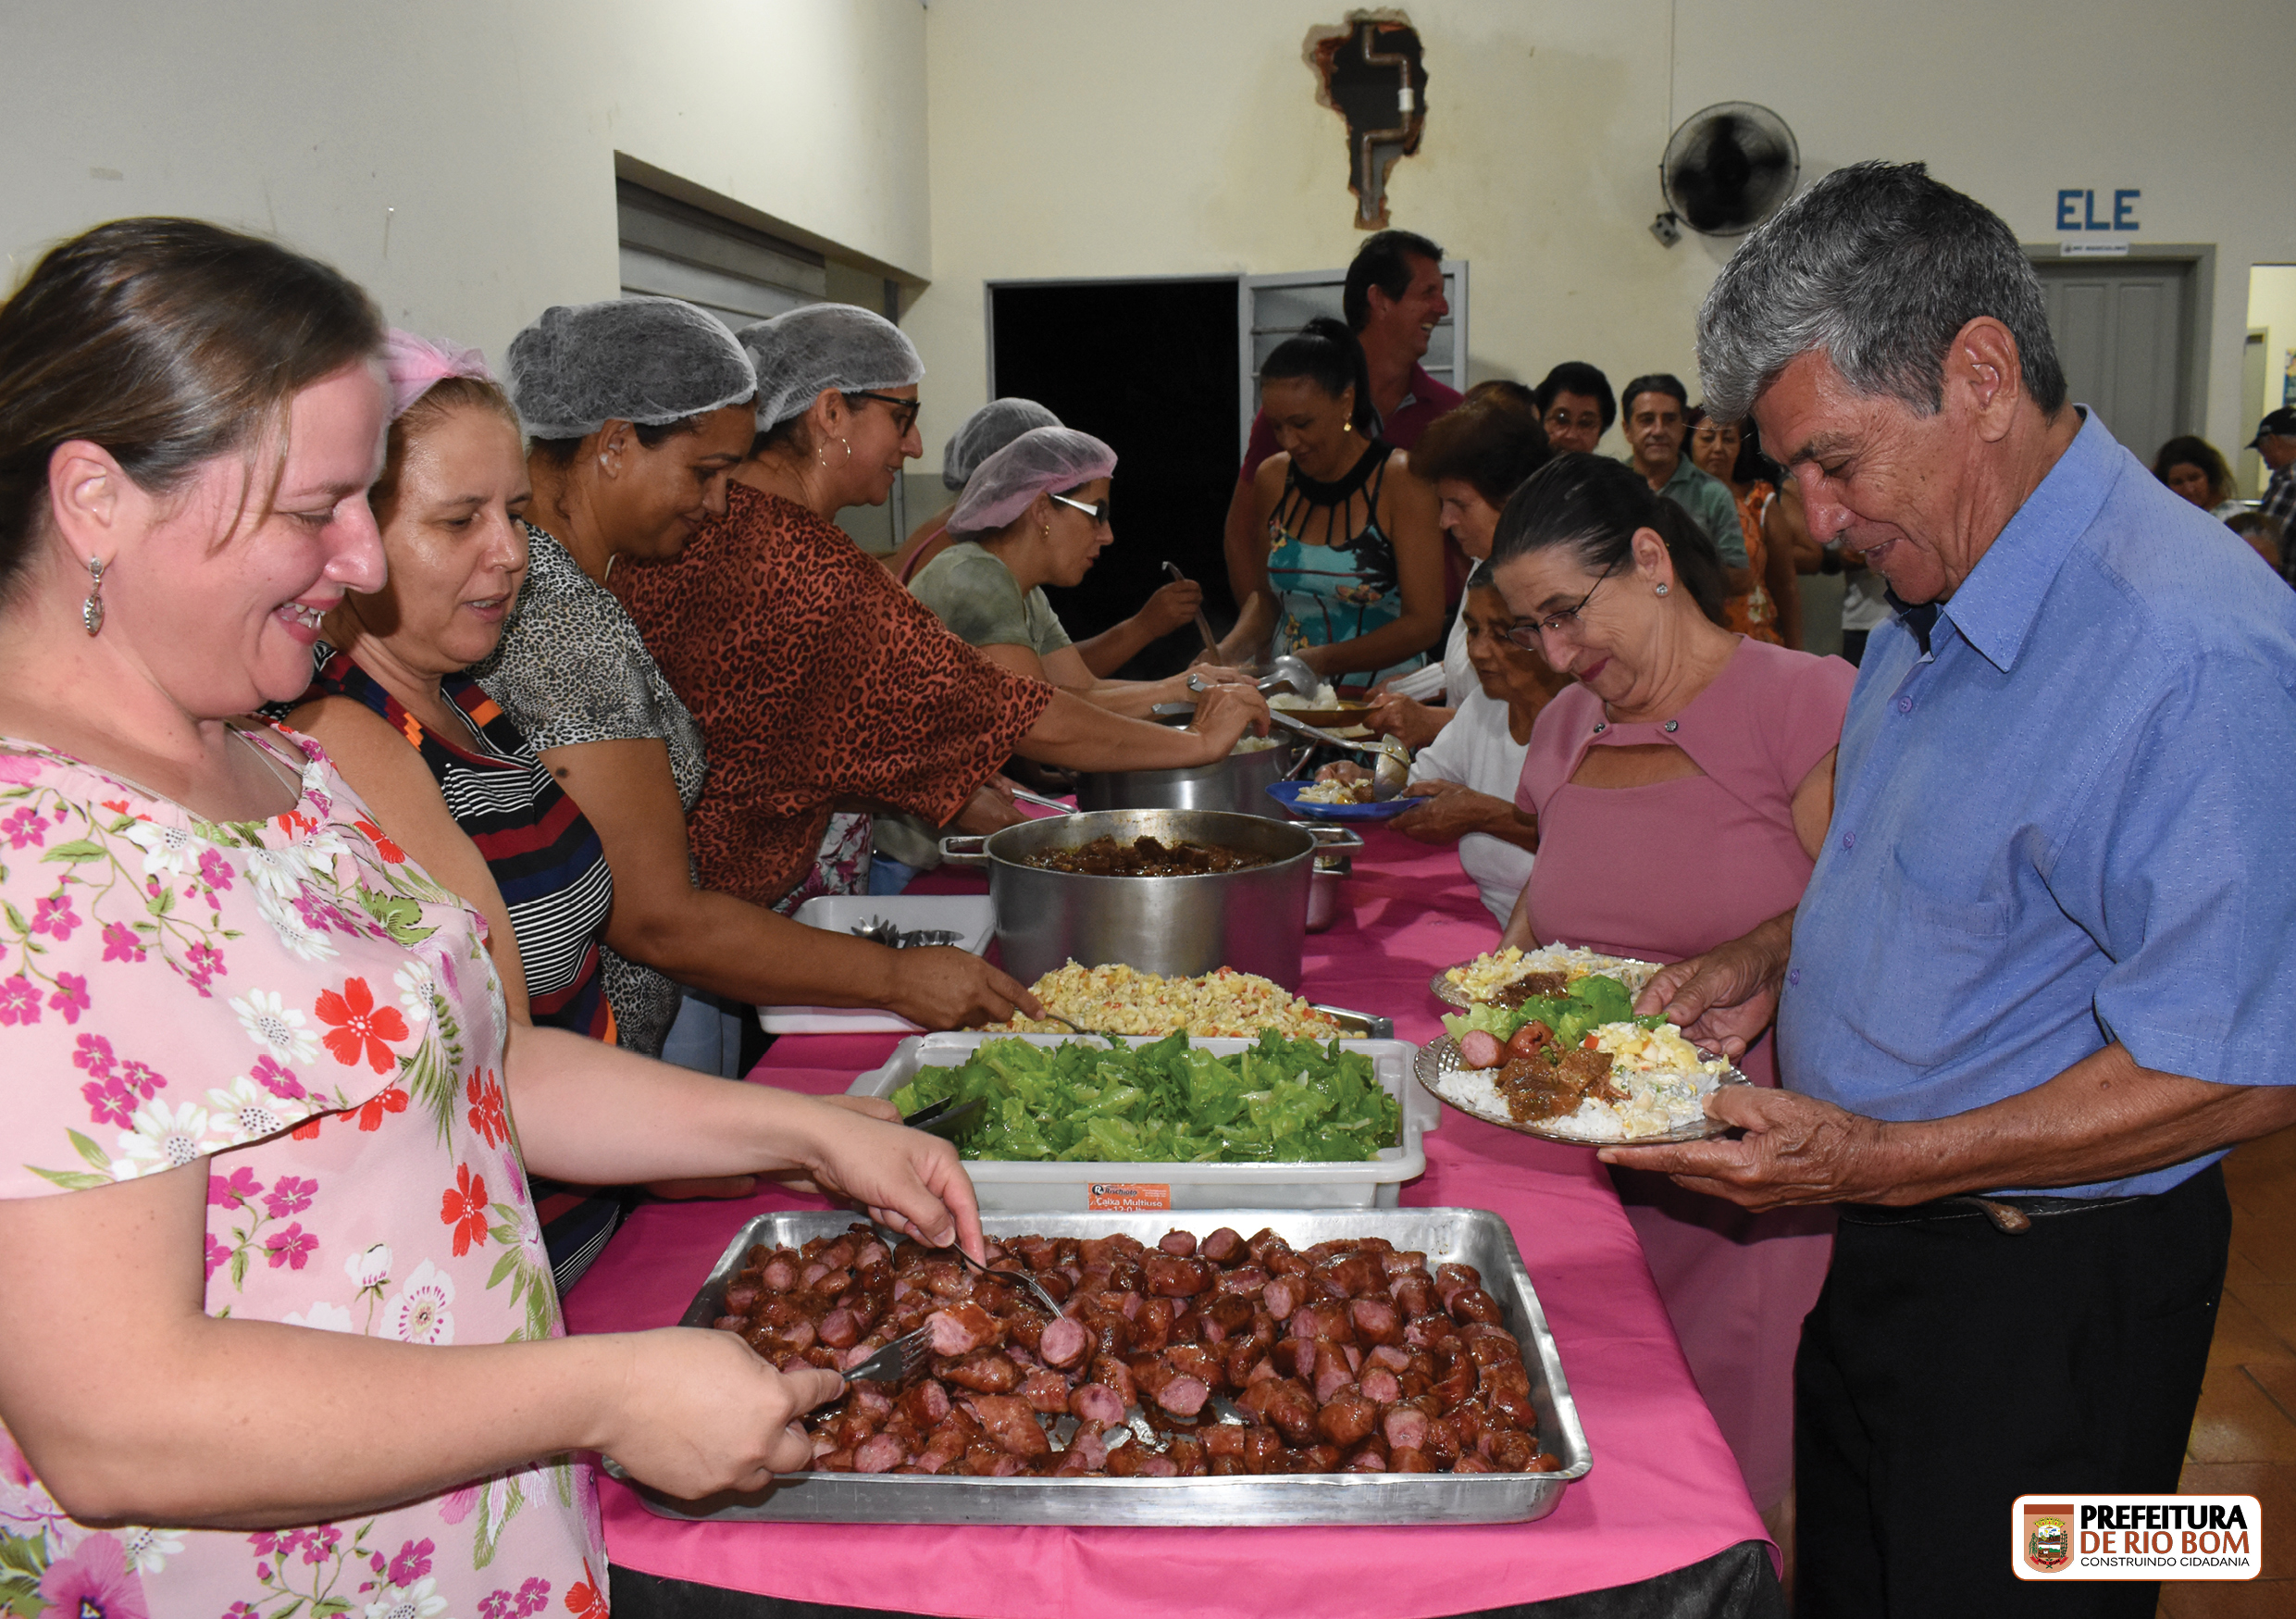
[847,1031,1442,1214]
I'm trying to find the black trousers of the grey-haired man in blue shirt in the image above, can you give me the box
[1793,1166,2232,1619]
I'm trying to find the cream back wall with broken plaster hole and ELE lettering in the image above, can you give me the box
[907,0,2296,467]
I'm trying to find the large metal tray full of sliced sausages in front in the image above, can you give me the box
[640,1208,1591,1525]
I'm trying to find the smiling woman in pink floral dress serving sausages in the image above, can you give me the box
[0,220,978,1619]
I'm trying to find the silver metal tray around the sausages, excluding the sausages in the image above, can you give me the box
[639,1208,1594,1525]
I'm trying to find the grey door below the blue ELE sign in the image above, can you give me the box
[2034,259,2192,464]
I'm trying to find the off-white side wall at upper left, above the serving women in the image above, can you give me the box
[0,0,932,358]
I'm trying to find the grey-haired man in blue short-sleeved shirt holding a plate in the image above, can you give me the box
[1605,163,2296,1619]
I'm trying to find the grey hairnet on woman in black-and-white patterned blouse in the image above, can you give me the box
[510,299,758,439]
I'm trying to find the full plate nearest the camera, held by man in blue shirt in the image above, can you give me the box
[1412,1022,1752,1146]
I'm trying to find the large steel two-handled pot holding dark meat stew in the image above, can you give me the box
[941,808,1322,990]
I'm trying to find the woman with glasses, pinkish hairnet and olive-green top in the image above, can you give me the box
[909,427,1245,716]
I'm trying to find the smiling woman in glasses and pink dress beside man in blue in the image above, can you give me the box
[1493,455,1855,1527]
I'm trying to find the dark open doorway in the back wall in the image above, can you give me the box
[989,276,1240,678]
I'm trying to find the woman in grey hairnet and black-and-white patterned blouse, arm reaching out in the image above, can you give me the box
[459,299,1026,1073]
